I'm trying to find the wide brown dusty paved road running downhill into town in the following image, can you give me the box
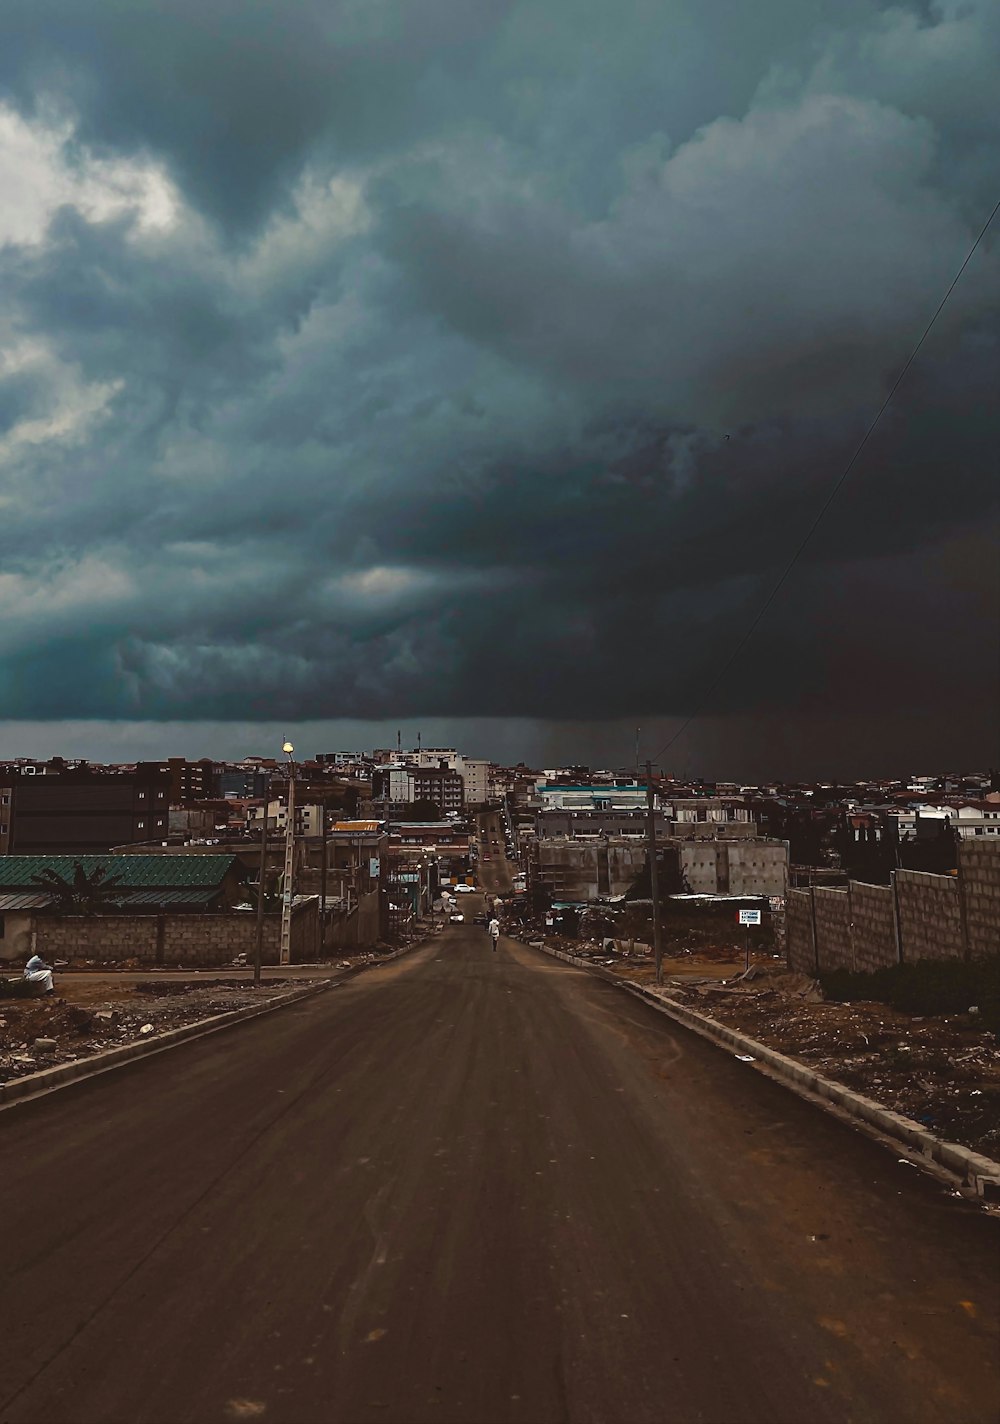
[0,897,1000,1424]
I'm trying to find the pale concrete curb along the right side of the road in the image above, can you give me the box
[524,940,1000,1202]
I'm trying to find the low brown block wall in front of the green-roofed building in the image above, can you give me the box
[36,901,319,968]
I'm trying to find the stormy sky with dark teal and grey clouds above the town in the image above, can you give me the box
[0,0,1000,775]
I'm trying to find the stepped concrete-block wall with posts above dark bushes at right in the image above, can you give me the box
[786,842,1000,974]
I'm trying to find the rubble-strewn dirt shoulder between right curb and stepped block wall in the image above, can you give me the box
[546,934,1000,1159]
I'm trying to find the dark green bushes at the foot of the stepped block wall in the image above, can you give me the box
[819,956,1000,1037]
